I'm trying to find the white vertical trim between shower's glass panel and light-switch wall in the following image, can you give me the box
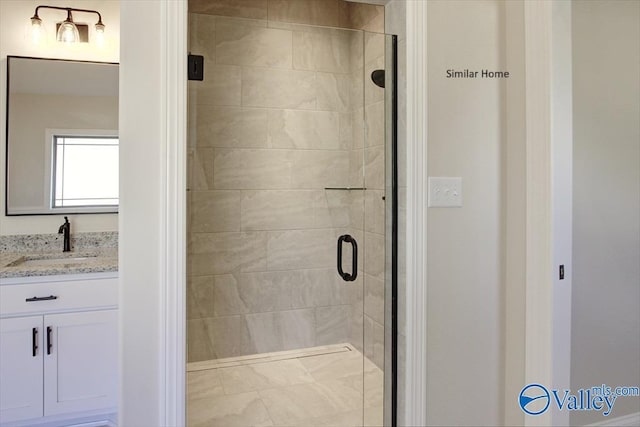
[400,1,428,426]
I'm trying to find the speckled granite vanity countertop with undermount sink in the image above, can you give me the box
[0,248,118,279]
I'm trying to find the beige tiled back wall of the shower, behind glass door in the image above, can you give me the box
[187,1,384,361]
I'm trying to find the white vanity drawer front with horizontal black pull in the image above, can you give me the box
[0,278,118,316]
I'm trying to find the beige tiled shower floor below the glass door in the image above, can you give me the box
[187,344,384,427]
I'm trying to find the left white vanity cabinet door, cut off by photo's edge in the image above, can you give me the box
[0,316,43,423]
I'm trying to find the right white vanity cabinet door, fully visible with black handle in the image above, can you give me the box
[44,310,118,415]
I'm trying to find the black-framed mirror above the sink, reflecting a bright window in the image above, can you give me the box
[5,56,119,215]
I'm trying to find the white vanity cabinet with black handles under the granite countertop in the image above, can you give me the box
[0,276,118,427]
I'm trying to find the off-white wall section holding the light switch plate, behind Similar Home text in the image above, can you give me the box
[427,0,506,426]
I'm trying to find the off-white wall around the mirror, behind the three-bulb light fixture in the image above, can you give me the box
[0,0,120,235]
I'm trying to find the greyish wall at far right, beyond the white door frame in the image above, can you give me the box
[571,0,640,425]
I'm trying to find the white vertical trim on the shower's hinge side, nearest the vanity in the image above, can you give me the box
[161,1,188,426]
